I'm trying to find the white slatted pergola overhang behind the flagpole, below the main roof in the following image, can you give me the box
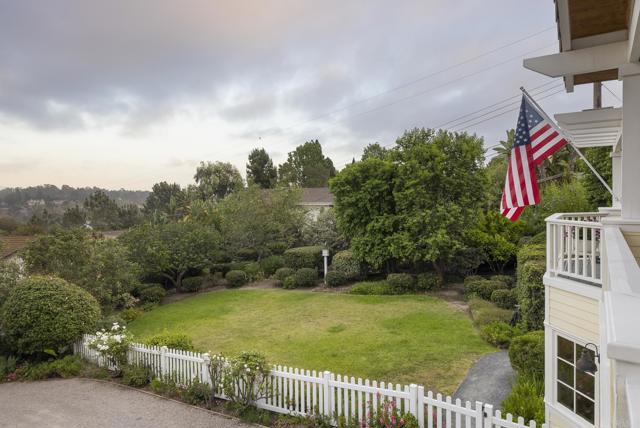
[554,108,622,148]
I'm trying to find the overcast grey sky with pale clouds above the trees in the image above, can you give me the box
[0,0,621,189]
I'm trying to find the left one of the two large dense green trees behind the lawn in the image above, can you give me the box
[329,158,398,270]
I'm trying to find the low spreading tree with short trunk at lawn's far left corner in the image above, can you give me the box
[119,221,220,291]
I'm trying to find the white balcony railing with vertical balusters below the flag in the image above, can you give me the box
[547,213,607,287]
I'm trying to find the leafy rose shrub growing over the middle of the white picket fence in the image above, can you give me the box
[223,352,269,406]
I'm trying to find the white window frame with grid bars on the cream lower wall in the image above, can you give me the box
[551,329,600,427]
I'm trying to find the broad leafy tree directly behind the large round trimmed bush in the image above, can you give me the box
[24,226,140,308]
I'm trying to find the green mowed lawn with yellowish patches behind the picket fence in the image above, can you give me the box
[130,289,495,393]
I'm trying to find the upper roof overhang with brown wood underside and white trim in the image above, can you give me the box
[524,0,640,92]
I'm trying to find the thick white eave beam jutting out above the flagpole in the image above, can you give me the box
[523,41,628,77]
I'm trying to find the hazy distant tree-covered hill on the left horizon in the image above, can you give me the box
[0,184,149,219]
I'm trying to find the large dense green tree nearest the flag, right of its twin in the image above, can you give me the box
[390,129,486,281]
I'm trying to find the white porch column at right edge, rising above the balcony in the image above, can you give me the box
[620,64,640,220]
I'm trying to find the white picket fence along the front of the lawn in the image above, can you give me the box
[74,335,546,428]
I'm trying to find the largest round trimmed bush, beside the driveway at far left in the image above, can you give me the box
[1,276,100,355]
